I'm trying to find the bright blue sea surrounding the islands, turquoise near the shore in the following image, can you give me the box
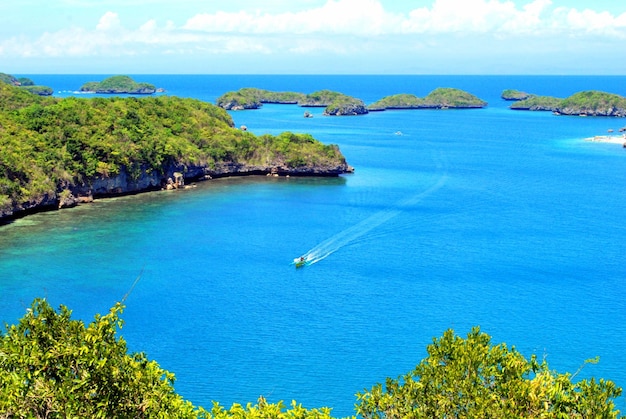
[0,74,626,417]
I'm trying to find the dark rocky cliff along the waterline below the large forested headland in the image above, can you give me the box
[0,161,354,222]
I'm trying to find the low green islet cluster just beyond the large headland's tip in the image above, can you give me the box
[216,87,367,115]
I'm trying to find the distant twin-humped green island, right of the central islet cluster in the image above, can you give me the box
[367,87,487,111]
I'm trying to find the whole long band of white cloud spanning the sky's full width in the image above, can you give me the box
[0,0,626,71]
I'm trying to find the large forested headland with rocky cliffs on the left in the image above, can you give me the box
[0,83,350,220]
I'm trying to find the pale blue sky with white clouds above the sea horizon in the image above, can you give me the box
[0,0,626,75]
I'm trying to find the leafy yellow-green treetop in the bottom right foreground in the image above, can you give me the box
[357,327,622,419]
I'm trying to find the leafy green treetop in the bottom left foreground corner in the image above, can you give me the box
[0,299,206,418]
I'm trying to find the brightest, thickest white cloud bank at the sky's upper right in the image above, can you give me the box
[178,0,626,38]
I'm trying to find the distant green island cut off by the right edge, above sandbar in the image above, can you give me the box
[510,90,626,117]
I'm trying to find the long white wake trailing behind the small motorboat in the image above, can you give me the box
[302,173,448,266]
